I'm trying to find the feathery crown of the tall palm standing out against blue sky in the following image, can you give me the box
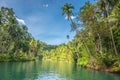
[62,3,74,21]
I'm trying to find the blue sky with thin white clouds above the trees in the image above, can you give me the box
[0,0,93,45]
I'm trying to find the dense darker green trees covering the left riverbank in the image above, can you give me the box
[0,7,45,61]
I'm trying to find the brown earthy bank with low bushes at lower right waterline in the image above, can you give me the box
[80,58,120,73]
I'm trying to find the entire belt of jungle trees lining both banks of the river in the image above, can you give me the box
[0,0,120,73]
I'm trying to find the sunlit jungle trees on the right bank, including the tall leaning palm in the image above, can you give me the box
[44,0,120,72]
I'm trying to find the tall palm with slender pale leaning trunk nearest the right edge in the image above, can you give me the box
[98,0,120,55]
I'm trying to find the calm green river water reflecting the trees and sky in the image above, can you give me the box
[0,61,120,80]
